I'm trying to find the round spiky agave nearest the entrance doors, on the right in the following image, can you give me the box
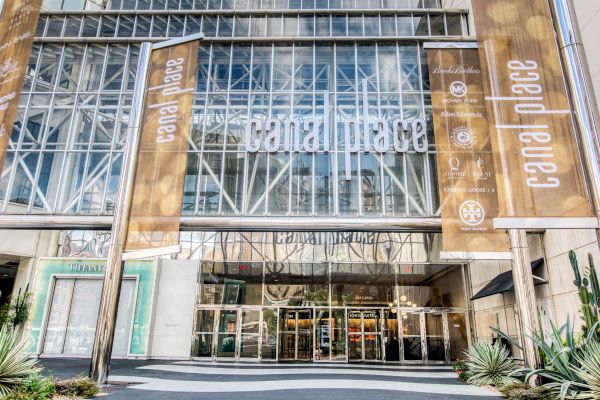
[465,342,519,387]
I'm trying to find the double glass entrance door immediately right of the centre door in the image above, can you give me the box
[348,309,383,361]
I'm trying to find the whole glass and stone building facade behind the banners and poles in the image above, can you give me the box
[0,0,600,363]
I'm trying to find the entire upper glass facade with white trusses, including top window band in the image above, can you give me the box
[0,0,466,217]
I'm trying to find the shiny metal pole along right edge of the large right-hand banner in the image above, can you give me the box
[550,0,600,244]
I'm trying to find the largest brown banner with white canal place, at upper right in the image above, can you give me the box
[472,0,597,228]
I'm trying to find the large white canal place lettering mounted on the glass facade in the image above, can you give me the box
[244,81,429,180]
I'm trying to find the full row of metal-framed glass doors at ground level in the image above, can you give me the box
[194,307,466,364]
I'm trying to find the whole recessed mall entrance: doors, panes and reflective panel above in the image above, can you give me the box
[191,233,470,364]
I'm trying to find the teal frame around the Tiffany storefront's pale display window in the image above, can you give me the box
[29,258,156,356]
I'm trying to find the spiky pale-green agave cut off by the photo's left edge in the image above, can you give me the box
[0,325,35,398]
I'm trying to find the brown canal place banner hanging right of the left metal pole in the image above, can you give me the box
[125,41,199,250]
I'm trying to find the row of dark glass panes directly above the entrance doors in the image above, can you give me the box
[198,256,468,310]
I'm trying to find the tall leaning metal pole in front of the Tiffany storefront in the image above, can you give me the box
[89,43,152,384]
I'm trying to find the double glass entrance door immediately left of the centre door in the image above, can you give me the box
[279,309,313,361]
